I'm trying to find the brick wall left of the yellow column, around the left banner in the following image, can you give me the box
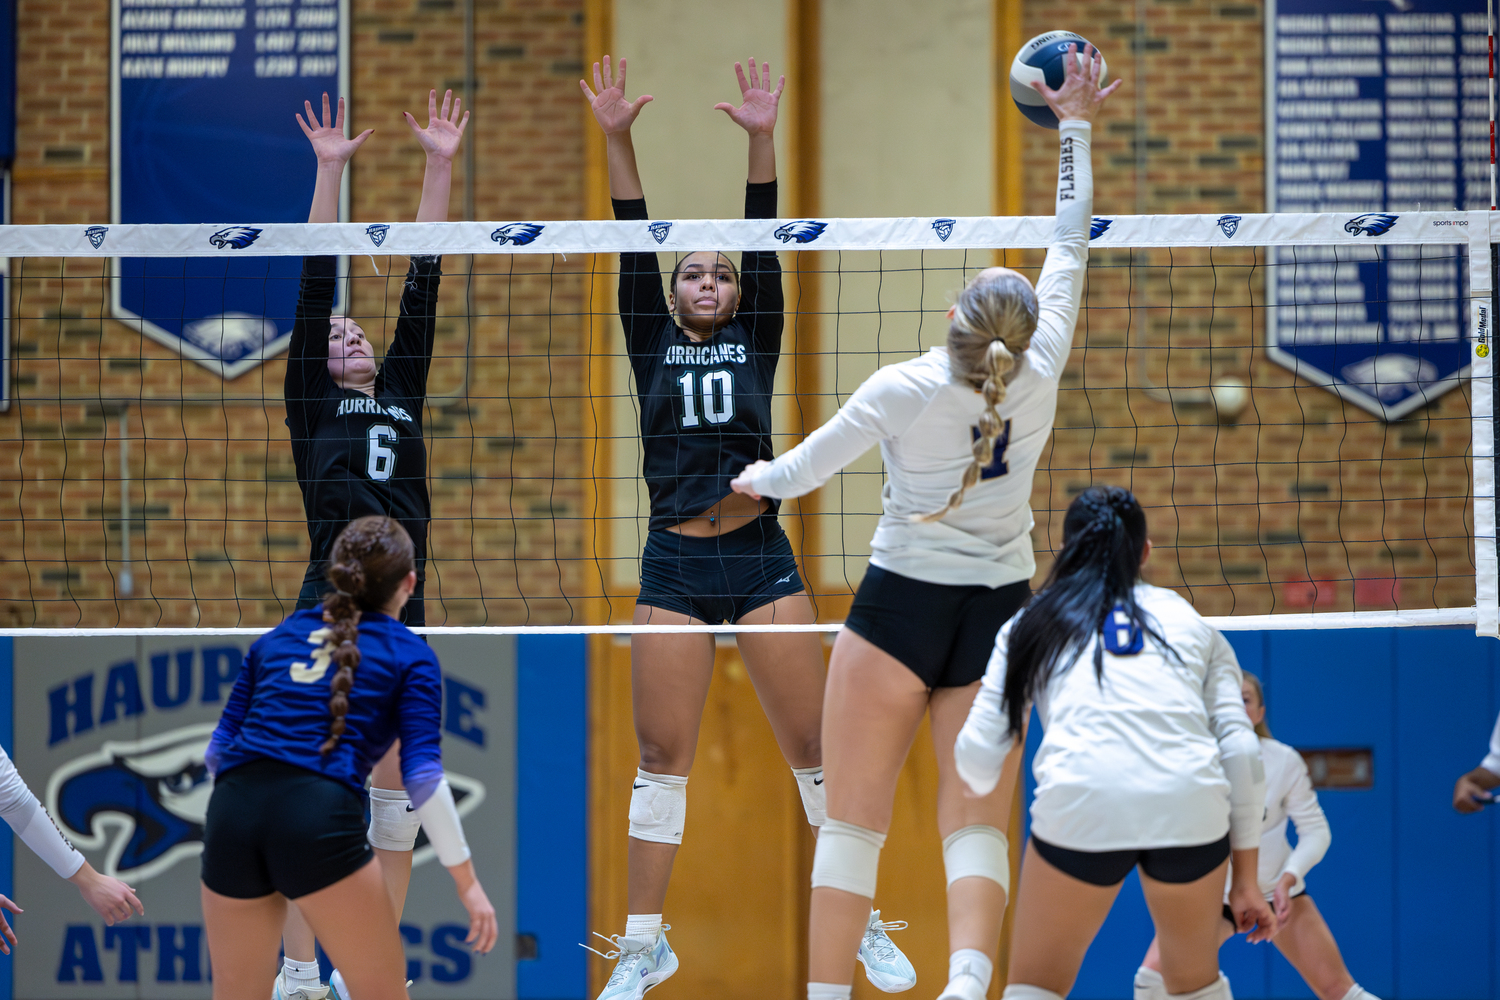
[0,0,590,625]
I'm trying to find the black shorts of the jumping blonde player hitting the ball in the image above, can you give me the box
[845,565,1031,688]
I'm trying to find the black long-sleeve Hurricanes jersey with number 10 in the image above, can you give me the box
[615,181,786,531]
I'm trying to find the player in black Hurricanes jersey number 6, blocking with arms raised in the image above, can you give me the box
[276,90,468,1000]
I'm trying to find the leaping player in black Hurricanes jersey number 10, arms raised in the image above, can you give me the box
[579,55,911,1000]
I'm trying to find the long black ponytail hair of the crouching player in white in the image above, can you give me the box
[1004,486,1172,738]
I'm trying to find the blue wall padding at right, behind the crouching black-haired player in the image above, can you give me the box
[1026,628,1500,1000]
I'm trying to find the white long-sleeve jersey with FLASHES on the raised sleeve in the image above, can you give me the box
[750,121,1094,588]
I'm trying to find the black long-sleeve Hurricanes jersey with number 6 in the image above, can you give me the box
[287,256,443,576]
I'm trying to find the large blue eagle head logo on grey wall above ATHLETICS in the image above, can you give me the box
[47,723,485,882]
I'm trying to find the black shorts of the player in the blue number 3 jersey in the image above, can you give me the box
[203,760,375,900]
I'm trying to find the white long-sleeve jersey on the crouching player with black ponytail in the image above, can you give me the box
[954,583,1265,852]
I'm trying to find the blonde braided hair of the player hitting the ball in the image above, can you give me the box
[912,268,1037,522]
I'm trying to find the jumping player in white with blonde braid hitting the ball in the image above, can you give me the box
[732,52,1119,1000]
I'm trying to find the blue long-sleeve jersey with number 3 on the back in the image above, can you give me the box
[206,607,443,808]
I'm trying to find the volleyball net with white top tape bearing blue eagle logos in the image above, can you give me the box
[0,211,1500,634]
